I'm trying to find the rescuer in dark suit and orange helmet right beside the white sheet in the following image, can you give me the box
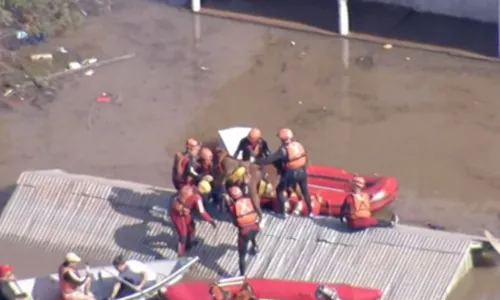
[233,127,271,162]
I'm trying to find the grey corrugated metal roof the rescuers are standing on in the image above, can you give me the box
[0,171,473,300]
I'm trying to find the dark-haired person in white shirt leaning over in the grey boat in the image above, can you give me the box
[108,255,156,299]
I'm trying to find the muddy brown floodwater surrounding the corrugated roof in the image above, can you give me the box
[0,1,500,300]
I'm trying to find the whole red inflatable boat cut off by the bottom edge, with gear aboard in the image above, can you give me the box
[165,277,382,300]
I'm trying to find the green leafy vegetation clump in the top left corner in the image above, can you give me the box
[0,0,83,35]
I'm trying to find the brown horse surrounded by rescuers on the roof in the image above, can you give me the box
[209,147,278,216]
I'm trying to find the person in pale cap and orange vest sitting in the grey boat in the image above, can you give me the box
[59,252,95,300]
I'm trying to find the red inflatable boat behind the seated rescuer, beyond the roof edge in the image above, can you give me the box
[307,165,398,216]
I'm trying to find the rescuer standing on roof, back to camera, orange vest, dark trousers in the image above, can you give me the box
[228,186,259,276]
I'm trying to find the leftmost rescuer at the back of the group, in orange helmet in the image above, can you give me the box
[172,138,201,190]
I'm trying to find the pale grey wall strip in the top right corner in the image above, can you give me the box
[363,0,499,23]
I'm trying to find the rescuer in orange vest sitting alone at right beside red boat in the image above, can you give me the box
[340,176,399,230]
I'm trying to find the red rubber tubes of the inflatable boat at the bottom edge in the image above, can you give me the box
[164,279,382,300]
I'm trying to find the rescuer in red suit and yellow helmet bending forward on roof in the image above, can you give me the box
[170,180,216,256]
